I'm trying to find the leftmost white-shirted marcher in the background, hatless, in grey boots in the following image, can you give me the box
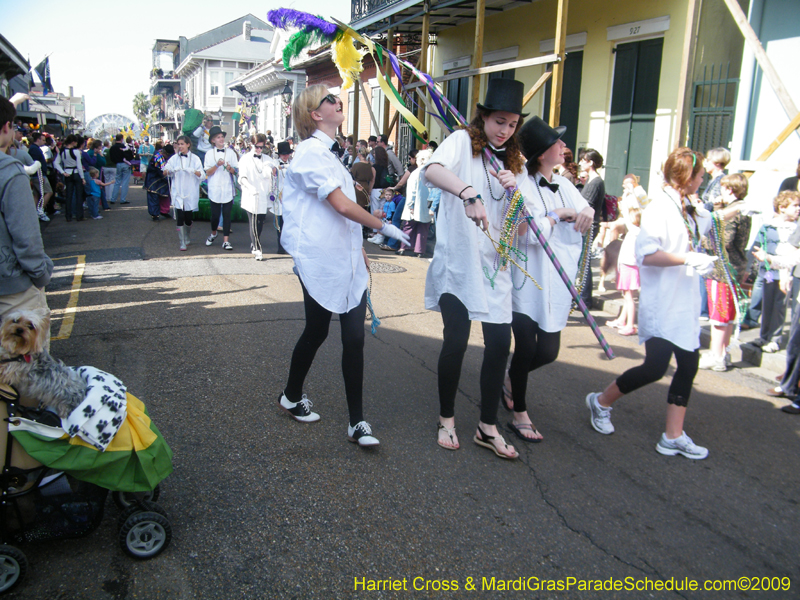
[163,135,204,251]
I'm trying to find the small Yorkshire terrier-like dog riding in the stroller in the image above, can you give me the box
[0,309,86,418]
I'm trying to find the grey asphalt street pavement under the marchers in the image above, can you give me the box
[9,187,800,600]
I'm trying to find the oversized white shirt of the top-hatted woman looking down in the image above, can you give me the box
[422,130,528,323]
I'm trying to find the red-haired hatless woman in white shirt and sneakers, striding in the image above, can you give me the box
[586,148,717,459]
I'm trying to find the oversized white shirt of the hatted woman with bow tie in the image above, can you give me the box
[511,173,589,333]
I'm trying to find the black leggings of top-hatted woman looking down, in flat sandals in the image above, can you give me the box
[438,294,511,425]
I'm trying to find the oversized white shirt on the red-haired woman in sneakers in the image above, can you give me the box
[636,187,711,352]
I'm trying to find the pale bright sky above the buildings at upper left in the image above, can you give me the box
[0,0,350,122]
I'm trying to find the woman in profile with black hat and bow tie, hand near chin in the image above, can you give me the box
[504,117,594,442]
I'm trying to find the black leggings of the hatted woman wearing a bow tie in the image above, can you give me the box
[508,312,561,412]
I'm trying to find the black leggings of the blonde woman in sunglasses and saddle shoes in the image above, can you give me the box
[284,281,367,426]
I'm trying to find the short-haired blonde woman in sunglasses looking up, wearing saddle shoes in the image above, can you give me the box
[278,85,408,446]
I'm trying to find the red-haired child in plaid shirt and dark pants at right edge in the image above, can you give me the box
[753,192,800,352]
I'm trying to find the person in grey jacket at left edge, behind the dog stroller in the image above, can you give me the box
[0,96,53,332]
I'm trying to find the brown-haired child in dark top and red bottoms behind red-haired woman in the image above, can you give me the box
[700,173,752,372]
